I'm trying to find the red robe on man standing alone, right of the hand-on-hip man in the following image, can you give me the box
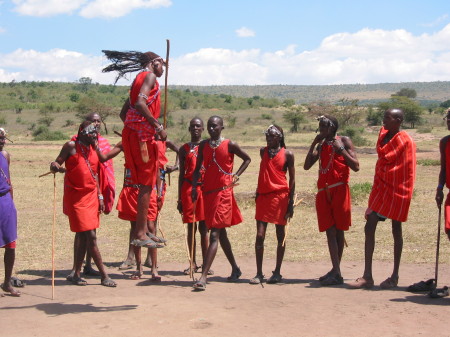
[255,147,289,225]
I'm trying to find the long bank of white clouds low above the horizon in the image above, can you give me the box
[0,24,450,85]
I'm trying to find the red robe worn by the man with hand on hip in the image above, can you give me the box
[202,139,242,228]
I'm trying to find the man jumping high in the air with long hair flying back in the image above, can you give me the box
[103,50,167,247]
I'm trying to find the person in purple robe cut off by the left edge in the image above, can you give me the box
[0,128,20,297]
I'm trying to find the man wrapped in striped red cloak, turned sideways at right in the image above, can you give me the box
[349,109,416,289]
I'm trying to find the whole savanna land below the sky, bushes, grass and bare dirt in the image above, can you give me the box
[0,78,450,336]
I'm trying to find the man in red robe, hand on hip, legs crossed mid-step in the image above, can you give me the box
[192,116,251,290]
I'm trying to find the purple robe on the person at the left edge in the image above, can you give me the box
[0,152,17,247]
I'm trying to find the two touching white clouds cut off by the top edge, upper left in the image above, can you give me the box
[12,0,172,18]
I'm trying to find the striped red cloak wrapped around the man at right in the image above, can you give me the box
[369,127,416,222]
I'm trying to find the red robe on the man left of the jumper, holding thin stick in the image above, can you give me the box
[63,142,100,232]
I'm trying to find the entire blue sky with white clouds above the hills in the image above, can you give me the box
[0,0,450,85]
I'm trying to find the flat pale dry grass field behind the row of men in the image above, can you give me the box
[1,124,450,274]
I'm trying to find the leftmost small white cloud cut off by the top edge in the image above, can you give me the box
[12,0,88,17]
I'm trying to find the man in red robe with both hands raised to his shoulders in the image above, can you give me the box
[303,116,359,286]
